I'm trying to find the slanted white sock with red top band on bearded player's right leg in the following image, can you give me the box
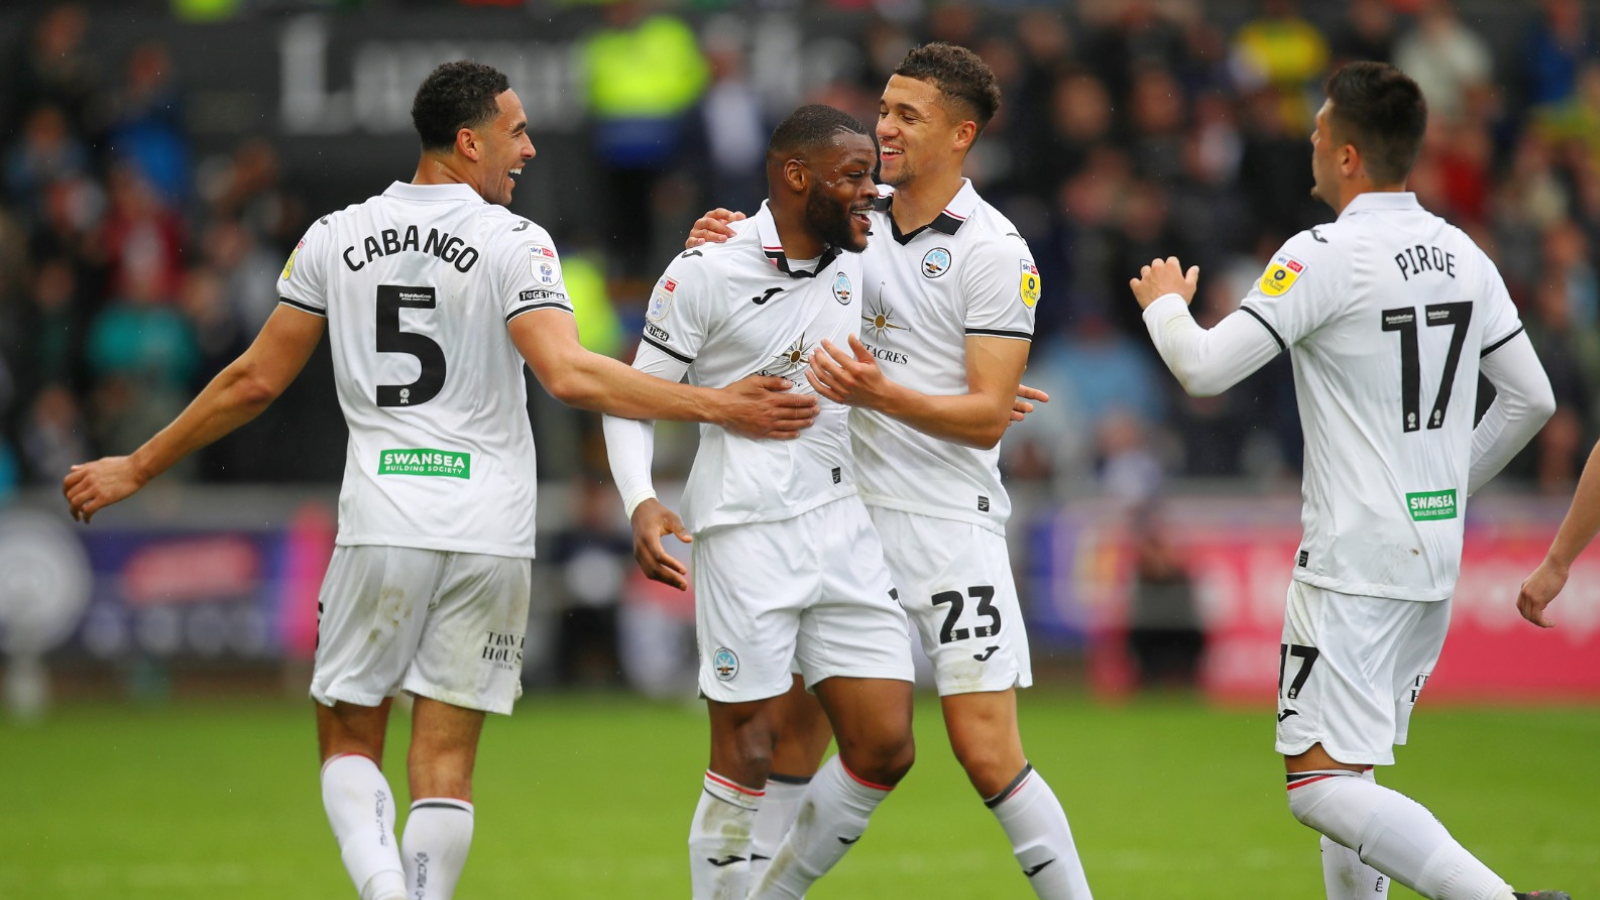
[750,756,891,900]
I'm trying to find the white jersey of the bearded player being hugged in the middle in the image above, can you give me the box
[643,203,861,533]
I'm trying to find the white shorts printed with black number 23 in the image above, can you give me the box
[870,506,1034,697]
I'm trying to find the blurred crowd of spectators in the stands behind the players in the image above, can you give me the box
[0,0,1600,501]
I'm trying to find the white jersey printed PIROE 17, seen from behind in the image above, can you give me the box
[1242,192,1522,601]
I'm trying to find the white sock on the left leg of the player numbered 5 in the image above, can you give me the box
[322,753,405,900]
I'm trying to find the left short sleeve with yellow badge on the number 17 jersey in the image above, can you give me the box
[1240,229,1339,349]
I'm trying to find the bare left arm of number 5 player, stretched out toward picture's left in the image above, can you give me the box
[61,304,326,522]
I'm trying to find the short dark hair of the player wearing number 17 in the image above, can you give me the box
[1323,62,1427,184]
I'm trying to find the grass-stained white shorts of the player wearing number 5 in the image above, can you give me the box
[310,544,533,713]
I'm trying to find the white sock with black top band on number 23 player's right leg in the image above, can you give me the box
[984,765,1091,900]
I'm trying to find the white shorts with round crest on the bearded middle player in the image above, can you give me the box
[693,496,914,703]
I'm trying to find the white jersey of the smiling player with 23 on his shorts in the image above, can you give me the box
[850,181,1040,533]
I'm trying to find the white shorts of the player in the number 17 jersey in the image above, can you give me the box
[1277,581,1450,765]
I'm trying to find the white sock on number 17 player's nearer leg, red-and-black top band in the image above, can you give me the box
[1288,769,1510,900]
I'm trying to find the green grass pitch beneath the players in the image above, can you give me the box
[0,690,1600,900]
